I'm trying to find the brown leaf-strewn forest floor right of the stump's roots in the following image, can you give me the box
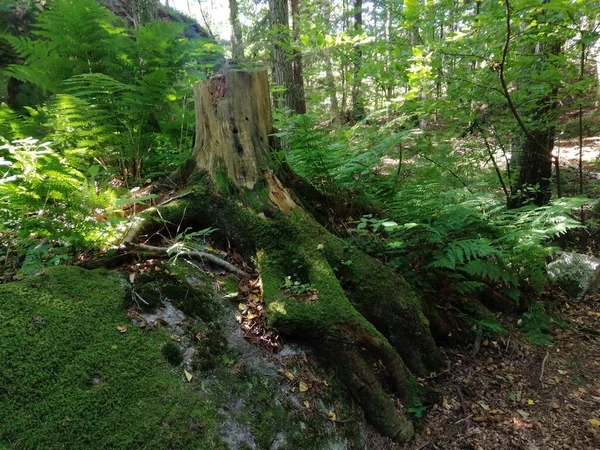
[408,293,600,450]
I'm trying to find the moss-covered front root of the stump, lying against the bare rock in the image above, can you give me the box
[258,248,418,442]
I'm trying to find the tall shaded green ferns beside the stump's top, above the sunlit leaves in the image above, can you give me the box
[0,0,220,178]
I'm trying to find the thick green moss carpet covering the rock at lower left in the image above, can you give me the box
[0,267,224,449]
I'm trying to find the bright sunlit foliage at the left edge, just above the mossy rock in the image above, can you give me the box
[0,138,118,273]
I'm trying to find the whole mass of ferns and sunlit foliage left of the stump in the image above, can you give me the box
[0,0,220,273]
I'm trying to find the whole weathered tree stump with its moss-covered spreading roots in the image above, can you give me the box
[170,71,445,441]
